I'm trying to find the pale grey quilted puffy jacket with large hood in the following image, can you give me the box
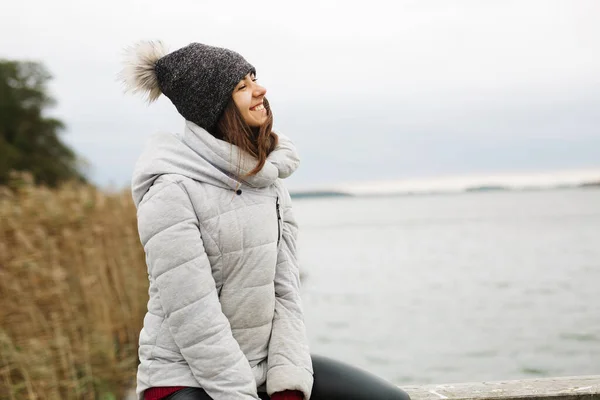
[132,121,313,400]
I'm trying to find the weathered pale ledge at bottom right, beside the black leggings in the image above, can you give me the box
[402,376,600,400]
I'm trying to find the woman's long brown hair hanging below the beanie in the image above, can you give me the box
[213,99,278,177]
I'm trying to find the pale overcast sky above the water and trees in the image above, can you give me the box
[0,0,600,188]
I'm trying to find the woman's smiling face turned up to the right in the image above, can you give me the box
[232,73,267,128]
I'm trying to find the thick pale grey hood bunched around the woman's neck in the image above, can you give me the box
[131,121,300,207]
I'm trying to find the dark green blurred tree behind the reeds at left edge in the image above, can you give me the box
[0,60,86,186]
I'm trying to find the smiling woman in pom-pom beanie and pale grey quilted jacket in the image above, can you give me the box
[123,42,408,400]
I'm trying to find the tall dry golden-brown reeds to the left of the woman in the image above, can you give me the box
[0,176,148,399]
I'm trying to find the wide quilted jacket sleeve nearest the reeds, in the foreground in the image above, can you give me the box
[138,181,258,400]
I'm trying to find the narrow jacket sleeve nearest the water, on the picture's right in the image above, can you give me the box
[267,186,313,400]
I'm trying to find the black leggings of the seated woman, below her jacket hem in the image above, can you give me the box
[166,355,410,400]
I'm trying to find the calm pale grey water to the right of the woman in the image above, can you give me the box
[294,188,600,385]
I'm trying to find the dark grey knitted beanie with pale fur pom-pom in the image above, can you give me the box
[121,42,256,131]
